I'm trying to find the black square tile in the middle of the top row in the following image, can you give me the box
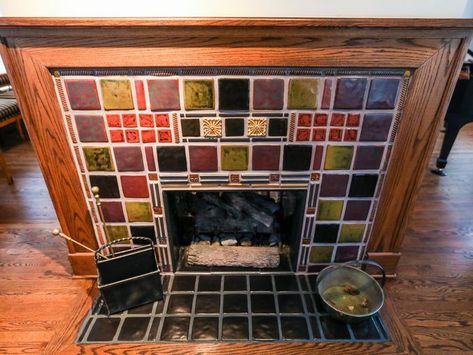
[218,79,250,110]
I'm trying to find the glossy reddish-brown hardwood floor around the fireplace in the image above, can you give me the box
[0,125,473,354]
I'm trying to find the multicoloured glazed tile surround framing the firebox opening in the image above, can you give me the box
[54,68,408,272]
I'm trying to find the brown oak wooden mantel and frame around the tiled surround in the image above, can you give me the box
[0,18,473,276]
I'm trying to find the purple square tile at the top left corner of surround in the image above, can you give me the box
[64,79,100,110]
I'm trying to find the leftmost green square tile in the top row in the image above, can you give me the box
[100,79,133,110]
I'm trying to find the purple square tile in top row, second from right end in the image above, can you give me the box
[333,78,367,109]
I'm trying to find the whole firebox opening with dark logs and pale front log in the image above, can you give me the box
[164,190,306,271]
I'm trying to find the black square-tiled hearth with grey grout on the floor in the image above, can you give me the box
[76,272,389,344]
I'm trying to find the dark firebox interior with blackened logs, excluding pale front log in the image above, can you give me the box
[164,190,306,271]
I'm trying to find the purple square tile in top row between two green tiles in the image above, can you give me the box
[148,79,181,111]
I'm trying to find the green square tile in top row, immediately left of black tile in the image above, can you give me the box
[184,80,215,110]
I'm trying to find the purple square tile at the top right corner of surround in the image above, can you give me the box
[366,79,400,109]
